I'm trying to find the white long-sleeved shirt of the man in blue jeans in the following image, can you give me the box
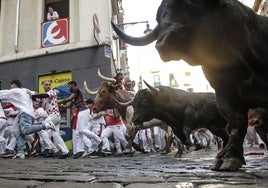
[0,88,35,118]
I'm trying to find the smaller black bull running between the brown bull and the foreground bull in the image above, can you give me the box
[132,82,229,153]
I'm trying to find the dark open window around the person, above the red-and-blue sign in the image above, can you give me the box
[44,0,69,21]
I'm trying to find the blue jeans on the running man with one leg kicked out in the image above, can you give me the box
[17,113,46,153]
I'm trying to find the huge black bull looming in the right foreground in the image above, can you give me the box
[112,0,268,170]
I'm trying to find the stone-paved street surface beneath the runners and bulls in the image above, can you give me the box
[0,147,268,188]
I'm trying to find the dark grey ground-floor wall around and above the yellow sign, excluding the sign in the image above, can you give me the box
[0,45,112,91]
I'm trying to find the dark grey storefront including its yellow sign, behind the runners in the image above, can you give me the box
[0,45,112,149]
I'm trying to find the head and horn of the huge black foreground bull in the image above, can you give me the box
[112,0,219,63]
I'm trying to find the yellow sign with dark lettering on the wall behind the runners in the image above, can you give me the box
[38,72,72,93]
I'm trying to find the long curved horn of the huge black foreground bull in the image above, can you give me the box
[111,22,159,46]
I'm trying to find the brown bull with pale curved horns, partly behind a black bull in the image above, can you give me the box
[84,69,180,155]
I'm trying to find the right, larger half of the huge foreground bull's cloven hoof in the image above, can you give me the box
[219,157,244,171]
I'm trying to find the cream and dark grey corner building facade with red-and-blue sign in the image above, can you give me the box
[0,0,122,90]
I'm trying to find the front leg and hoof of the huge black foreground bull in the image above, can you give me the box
[211,96,247,171]
